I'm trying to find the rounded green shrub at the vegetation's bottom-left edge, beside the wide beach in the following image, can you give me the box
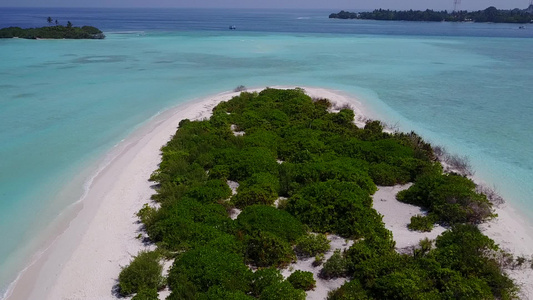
[118,252,165,296]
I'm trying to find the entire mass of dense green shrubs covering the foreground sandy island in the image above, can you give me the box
[121,89,515,300]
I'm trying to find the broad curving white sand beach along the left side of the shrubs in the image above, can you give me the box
[7,88,243,299]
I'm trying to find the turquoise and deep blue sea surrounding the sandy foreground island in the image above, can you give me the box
[0,8,533,298]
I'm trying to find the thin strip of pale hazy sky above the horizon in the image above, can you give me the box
[0,0,530,10]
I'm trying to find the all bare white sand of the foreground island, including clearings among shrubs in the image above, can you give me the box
[7,87,533,300]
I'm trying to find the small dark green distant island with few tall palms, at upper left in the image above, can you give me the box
[0,21,105,40]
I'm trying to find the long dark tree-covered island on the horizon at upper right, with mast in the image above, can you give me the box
[329,5,533,23]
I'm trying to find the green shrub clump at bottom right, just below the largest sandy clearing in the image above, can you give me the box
[329,225,516,299]
